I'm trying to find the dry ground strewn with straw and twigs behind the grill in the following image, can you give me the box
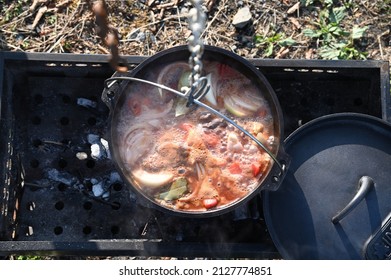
[0,0,391,61]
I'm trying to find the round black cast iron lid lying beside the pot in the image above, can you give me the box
[263,114,391,259]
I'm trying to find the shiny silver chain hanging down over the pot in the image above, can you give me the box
[188,0,206,84]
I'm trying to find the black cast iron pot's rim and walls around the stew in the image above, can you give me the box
[102,46,288,217]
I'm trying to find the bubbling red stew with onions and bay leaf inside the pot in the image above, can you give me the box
[115,61,278,211]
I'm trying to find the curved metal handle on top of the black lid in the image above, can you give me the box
[331,176,375,224]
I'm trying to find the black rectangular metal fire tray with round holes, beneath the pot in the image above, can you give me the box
[0,53,391,258]
